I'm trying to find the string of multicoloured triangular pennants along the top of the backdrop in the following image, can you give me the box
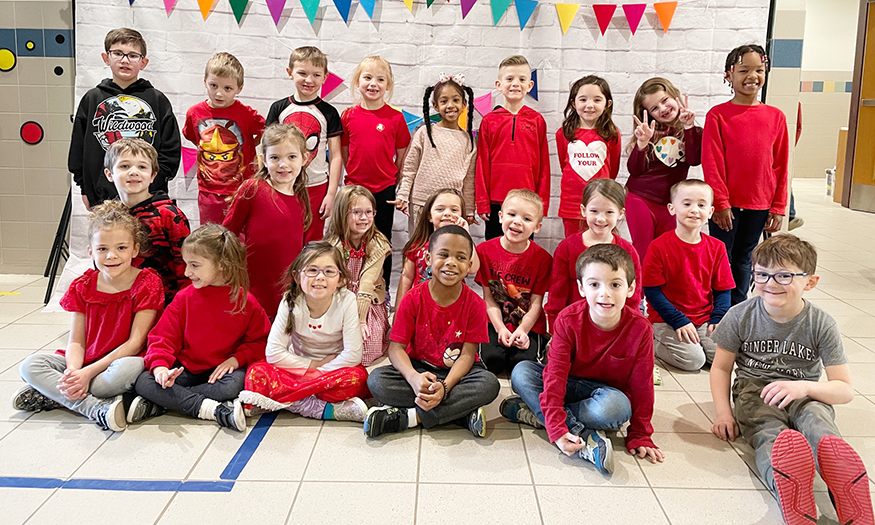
[154,0,678,35]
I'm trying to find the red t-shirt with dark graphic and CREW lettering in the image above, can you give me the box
[474,237,553,335]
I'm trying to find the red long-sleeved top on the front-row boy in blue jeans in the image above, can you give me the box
[540,301,655,450]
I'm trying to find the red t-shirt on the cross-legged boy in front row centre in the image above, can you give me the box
[389,282,489,368]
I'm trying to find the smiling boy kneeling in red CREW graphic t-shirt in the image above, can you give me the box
[475,190,553,374]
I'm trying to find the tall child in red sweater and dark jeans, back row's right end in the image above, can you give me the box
[702,45,789,305]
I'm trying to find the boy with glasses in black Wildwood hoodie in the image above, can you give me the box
[67,27,181,209]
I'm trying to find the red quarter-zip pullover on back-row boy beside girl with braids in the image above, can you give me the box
[475,106,550,217]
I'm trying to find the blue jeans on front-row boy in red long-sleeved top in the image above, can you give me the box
[510,361,632,435]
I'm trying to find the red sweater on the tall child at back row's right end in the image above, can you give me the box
[702,101,789,215]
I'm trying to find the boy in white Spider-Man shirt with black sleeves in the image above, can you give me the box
[267,46,343,243]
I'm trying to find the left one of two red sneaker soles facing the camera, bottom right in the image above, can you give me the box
[772,429,820,525]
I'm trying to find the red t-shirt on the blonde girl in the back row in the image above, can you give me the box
[340,104,410,193]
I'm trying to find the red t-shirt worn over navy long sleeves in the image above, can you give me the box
[641,231,735,326]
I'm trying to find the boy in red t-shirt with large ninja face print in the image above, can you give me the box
[182,53,264,224]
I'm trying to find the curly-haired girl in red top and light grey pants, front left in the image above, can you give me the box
[12,201,164,432]
